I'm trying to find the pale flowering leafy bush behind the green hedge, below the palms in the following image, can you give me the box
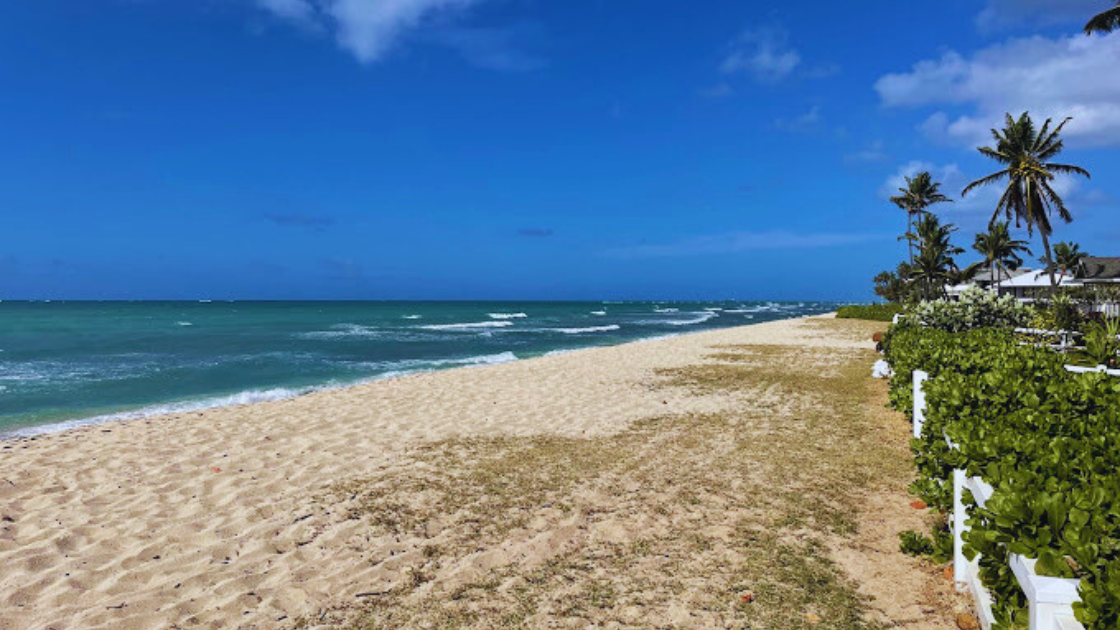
[906,288,1030,333]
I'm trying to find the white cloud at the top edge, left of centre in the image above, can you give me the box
[254,0,508,64]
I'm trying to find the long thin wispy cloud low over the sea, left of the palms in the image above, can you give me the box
[604,231,894,259]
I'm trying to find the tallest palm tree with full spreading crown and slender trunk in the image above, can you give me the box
[961,112,1090,288]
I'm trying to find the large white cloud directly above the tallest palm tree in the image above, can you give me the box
[875,34,1120,146]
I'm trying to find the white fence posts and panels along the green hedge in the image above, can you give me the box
[914,370,1084,630]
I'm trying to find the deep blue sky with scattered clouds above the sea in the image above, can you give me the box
[0,0,1120,299]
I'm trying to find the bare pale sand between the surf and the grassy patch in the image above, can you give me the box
[0,321,870,630]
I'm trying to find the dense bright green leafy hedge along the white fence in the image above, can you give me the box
[886,326,1120,630]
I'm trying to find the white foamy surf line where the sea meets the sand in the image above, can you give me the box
[0,312,815,445]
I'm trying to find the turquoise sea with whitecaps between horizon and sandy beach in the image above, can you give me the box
[0,302,834,436]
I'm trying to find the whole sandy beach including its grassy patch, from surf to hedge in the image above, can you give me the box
[0,317,959,630]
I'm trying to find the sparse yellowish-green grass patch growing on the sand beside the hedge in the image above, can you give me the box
[309,321,909,630]
